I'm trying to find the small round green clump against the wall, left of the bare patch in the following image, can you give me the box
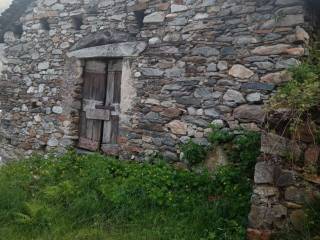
[180,139,207,165]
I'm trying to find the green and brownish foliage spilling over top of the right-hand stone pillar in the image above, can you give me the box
[268,50,320,141]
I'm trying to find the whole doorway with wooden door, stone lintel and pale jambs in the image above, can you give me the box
[65,38,147,156]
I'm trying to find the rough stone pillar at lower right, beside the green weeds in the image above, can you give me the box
[248,130,320,240]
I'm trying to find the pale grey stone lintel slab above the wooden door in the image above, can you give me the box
[67,42,147,58]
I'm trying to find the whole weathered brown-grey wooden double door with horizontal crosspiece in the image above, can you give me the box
[79,60,122,154]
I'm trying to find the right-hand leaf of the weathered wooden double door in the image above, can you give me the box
[101,60,122,155]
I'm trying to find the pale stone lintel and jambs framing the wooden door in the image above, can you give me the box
[65,42,147,155]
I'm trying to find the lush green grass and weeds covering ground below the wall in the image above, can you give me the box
[0,128,259,240]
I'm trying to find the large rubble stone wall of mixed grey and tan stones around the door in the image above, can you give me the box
[0,0,307,162]
